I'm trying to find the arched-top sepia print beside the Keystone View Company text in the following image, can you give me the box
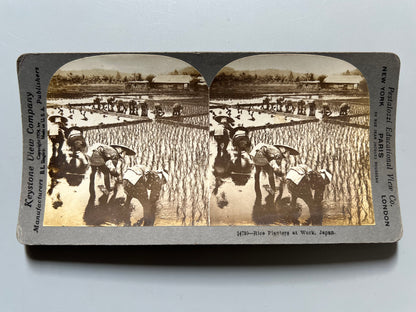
[43,54,209,226]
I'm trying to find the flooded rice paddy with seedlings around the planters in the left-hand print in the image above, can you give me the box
[44,94,209,226]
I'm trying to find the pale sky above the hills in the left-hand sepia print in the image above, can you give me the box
[60,54,195,75]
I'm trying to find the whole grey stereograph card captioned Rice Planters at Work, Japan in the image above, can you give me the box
[17,52,402,245]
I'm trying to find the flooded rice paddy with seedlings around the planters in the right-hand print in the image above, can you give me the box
[209,96,374,225]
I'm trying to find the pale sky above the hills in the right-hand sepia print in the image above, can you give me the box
[227,54,356,75]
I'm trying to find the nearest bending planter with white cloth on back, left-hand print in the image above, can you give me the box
[123,165,169,226]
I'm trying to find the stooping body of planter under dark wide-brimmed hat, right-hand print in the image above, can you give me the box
[250,143,285,195]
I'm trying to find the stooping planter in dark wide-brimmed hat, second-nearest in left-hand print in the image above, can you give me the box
[88,143,136,194]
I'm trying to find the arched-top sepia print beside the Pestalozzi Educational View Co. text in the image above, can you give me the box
[209,54,375,226]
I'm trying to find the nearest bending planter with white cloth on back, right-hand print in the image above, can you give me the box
[286,165,332,225]
